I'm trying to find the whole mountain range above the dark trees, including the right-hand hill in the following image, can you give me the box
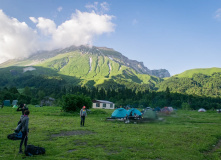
[0,46,221,100]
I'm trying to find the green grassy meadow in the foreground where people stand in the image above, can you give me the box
[0,105,221,160]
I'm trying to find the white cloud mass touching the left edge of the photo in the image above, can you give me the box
[0,10,38,62]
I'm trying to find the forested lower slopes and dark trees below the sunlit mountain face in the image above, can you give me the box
[0,63,221,109]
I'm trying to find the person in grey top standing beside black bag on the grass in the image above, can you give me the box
[19,110,30,153]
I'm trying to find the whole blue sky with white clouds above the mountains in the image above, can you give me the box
[0,0,221,75]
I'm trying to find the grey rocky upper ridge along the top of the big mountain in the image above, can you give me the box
[0,46,170,78]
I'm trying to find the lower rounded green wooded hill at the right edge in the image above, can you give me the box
[156,68,221,97]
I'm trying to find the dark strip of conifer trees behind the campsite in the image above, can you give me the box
[0,85,221,109]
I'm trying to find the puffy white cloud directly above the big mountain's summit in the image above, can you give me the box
[33,10,114,49]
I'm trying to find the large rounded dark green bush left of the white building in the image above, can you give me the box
[60,94,92,112]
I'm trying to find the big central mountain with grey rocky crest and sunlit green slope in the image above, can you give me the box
[0,46,170,88]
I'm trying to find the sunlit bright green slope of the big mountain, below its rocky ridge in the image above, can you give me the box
[37,51,160,86]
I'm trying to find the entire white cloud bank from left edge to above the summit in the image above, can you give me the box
[0,10,115,63]
